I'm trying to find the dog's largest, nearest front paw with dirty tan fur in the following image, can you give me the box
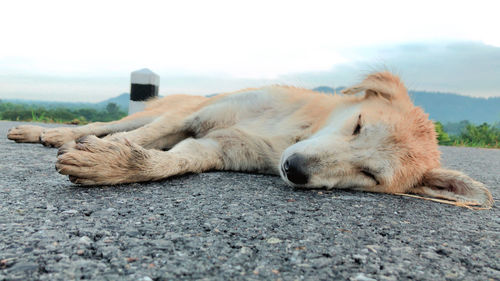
[56,136,149,185]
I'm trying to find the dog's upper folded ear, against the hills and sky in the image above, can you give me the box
[341,71,410,102]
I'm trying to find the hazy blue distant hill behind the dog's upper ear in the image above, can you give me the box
[313,86,500,124]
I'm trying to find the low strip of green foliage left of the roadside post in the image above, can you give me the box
[0,102,127,124]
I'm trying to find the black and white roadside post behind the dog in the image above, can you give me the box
[128,68,160,115]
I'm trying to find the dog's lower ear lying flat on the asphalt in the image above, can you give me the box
[411,168,493,208]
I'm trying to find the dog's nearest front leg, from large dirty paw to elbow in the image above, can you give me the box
[56,136,223,185]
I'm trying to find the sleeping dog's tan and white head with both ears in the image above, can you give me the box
[280,72,492,206]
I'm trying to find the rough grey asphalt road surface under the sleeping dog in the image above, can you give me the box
[0,122,500,281]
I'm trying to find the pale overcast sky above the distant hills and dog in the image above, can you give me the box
[0,0,500,101]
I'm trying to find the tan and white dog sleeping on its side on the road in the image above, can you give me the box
[8,72,493,208]
